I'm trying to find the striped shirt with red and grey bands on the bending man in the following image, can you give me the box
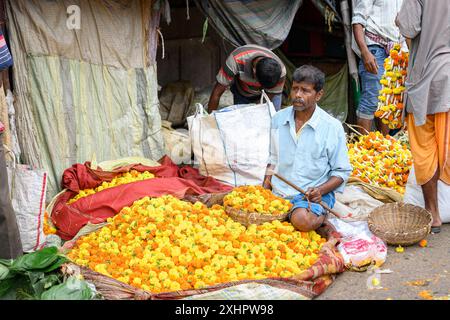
[216,45,286,97]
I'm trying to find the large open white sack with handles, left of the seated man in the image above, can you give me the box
[188,94,275,186]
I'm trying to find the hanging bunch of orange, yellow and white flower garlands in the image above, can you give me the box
[375,44,409,129]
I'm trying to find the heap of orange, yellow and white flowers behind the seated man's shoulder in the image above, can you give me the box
[348,132,412,194]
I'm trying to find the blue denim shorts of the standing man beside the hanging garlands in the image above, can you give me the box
[356,45,388,120]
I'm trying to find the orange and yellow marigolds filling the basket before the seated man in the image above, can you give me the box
[223,186,292,215]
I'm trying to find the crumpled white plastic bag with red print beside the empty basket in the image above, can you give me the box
[329,218,387,269]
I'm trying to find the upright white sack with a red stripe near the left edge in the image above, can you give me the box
[7,148,47,252]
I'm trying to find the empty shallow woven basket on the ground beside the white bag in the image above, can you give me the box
[368,202,432,246]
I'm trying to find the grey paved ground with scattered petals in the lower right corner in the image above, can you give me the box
[317,224,450,300]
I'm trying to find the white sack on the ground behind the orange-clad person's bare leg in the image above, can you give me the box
[403,166,450,223]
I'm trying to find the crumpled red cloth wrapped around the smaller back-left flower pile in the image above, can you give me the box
[51,156,232,240]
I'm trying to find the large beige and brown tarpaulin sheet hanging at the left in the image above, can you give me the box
[7,0,164,199]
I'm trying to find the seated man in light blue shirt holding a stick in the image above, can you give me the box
[264,65,352,232]
